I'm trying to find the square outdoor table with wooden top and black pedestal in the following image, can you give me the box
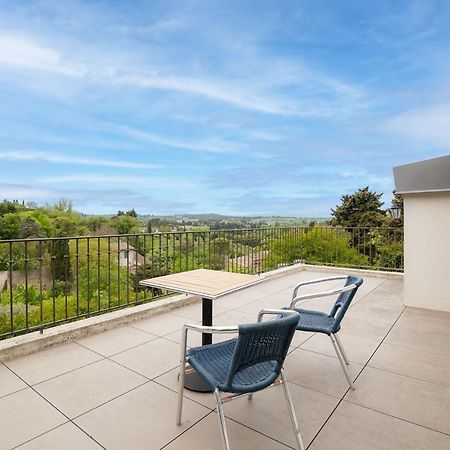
[140,269,264,392]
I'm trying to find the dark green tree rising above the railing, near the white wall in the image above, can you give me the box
[331,186,386,228]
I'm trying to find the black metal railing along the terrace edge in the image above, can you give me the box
[0,227,403,339]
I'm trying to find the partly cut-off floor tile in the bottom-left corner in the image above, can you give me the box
[0,388,67,450]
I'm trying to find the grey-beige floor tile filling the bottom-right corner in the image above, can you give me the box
[310,401,450,450]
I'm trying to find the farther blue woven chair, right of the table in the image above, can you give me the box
[289,275,363,389]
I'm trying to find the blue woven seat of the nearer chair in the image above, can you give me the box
[187,339,277,393]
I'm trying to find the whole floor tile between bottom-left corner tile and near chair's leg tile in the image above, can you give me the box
[35,360,147,418]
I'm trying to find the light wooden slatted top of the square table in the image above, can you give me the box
[139,269,264,299]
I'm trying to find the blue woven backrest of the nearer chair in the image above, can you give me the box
[224,315,300,393]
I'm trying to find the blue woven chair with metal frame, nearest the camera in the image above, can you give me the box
[177,309,304,450]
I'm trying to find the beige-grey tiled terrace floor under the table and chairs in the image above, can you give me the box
[0,271,450,450]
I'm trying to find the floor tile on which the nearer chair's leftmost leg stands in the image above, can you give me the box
[75,382,210,450]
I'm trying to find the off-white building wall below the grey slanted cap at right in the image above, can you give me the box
[403,192,450,312]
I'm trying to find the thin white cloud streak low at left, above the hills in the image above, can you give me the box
[0,151,162,169]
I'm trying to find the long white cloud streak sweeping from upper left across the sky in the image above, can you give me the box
[0,34,366,117]
